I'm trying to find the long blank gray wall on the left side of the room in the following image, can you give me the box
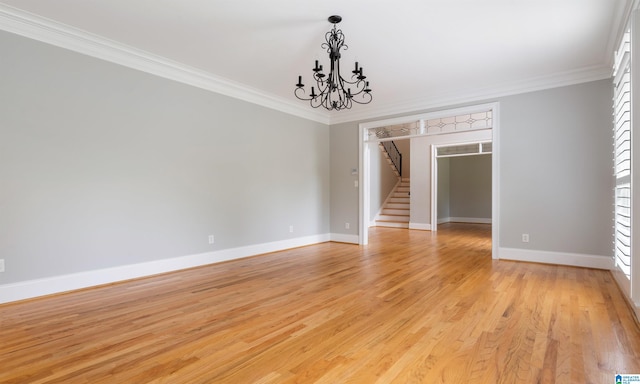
[0,32,330,284]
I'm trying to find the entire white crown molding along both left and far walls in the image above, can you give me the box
[0,0,620,125]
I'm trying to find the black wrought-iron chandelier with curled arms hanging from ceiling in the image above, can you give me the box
[294,15,372,111]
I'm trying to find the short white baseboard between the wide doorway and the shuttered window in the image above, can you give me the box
[500,248,613,270]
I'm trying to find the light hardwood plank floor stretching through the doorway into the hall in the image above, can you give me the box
[0,224,640,384]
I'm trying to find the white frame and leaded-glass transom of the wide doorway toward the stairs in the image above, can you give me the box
[359,102,500,259]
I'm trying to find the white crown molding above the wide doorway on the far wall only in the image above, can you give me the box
[330,65,612,124]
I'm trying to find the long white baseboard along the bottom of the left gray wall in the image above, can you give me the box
[0,234,330,304]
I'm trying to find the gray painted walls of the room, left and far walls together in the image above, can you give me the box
[0,27,613,284]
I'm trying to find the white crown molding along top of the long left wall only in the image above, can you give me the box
[0,4,329,125]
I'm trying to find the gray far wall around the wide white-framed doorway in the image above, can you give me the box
[331,79,613,255]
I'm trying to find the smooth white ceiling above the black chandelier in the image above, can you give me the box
[0,0,631,122]
